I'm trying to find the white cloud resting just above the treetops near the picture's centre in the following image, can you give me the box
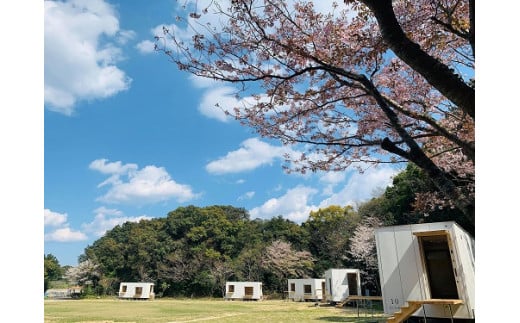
[249,186,317,223]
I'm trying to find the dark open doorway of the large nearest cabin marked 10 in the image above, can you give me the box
[420,235,459,299]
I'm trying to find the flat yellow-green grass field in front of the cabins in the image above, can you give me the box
[44,298,384,323]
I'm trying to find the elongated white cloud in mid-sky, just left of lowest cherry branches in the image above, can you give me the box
[206,138,291,174]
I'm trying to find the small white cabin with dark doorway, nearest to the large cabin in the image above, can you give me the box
[324,268,361,303]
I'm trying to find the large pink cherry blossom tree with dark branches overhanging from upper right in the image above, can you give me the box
[156,0,475,222]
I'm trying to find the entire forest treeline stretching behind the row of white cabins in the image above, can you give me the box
[44,165,474,297]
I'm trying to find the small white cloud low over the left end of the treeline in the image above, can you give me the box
[82,207,152,237]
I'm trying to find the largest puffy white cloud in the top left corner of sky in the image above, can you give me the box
[44,0,134,115]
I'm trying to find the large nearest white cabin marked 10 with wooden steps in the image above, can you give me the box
[375,221,475,319]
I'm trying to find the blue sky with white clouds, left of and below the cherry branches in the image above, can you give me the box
[44,0,402,266]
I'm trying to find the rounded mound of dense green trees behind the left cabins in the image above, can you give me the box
[84,206,312,296]
